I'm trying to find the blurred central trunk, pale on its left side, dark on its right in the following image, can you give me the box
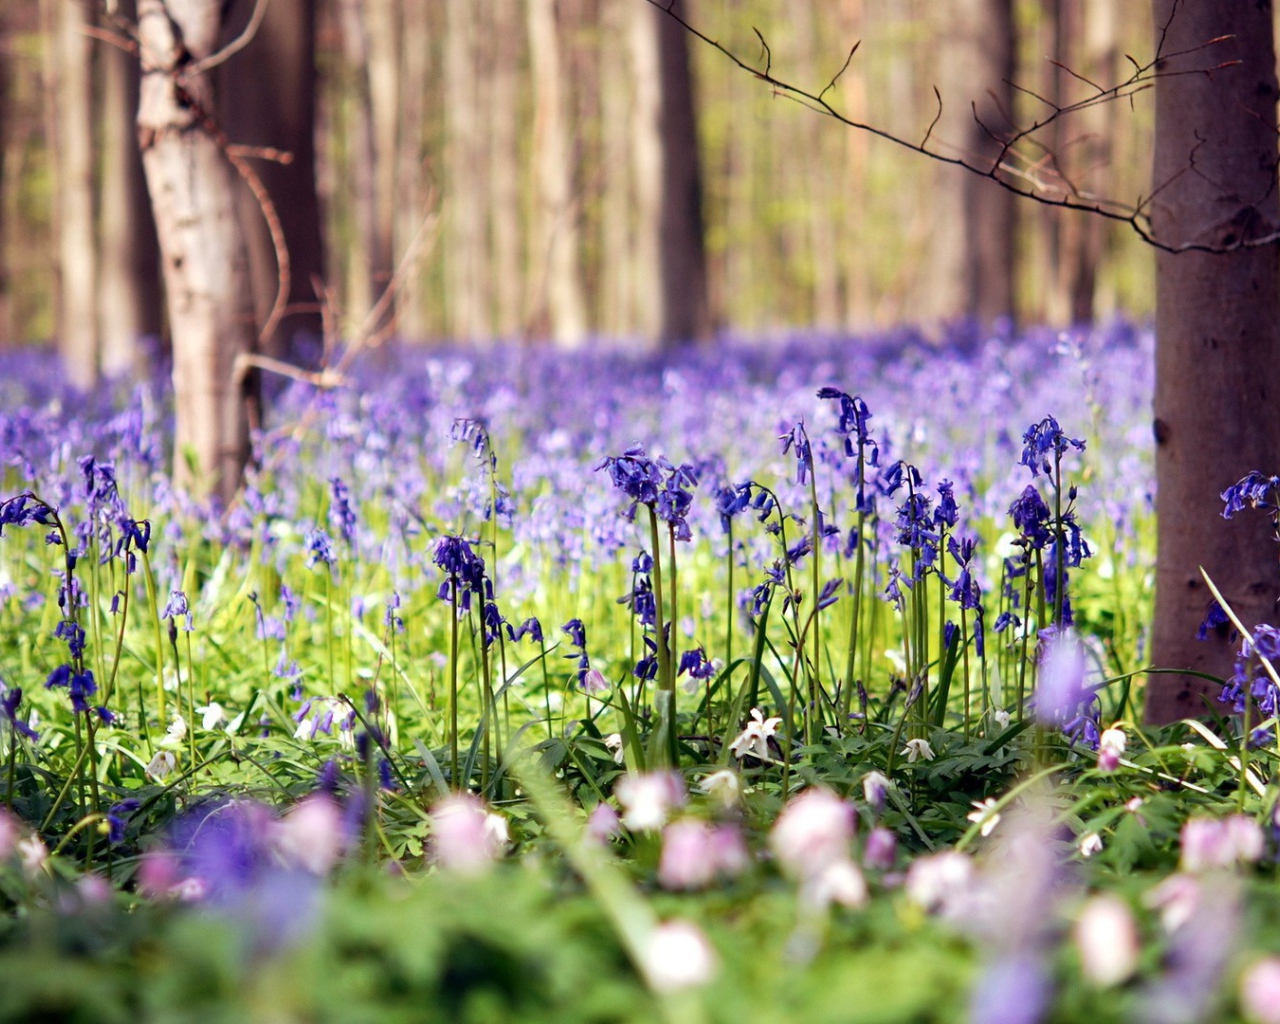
[631,4,709,346]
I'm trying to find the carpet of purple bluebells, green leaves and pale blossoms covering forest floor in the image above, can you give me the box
[0,324,1280,1024]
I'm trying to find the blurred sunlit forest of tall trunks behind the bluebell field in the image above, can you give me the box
[0,0,1153,383]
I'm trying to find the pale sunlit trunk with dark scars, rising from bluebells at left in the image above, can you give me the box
[138,0,256,502]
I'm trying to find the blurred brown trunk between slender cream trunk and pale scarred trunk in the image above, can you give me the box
[97,0,164,376]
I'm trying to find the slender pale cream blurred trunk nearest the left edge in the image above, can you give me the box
[50,0,99,388]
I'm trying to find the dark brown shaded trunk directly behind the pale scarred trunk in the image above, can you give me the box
[216,0,325,358]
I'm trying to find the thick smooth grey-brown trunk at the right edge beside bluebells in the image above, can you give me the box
[1147,0,1280,722]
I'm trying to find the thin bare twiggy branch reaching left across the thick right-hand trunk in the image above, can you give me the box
[645,0,1280,253]
